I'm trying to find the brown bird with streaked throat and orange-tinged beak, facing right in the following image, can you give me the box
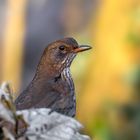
[14,37,92,117]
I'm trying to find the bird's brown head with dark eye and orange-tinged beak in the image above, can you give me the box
[36,38,91,76]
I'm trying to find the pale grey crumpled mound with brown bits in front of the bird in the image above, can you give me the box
[0,82,90,140]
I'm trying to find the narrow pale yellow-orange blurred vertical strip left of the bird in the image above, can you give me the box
[2,0,26,91]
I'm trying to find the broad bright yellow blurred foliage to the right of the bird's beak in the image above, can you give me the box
[77,0,140,130]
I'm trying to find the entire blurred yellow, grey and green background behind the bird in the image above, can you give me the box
[0,0,140,140]
